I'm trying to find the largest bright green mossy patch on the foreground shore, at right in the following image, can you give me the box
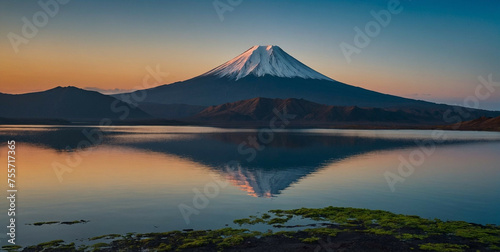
[235,207,500,249]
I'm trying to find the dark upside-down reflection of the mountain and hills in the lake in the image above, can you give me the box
[0,127,488,197]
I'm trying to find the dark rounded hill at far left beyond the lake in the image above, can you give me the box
[0,87,151,121]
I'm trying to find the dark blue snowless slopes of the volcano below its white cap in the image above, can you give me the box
[130,75,430,107]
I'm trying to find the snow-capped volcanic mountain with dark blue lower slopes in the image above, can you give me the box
[120,45,446,108]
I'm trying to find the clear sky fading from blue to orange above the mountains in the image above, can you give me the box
[0,0,500,110]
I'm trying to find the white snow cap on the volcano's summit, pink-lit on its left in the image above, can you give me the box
[202,45,333,81]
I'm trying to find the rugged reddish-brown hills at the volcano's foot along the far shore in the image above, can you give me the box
[187,97,500,128]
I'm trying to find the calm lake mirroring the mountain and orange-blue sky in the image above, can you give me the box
[0,126,500,245]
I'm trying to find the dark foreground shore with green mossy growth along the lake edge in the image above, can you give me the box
[2,206,500,252]
